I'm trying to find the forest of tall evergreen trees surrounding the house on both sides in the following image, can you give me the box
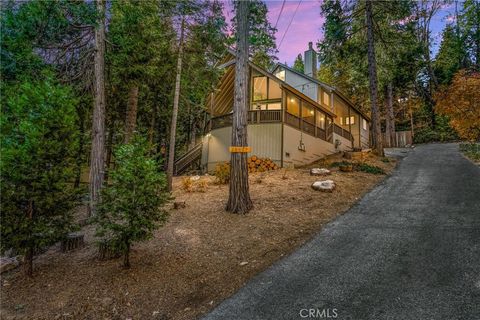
[0,0,480,275]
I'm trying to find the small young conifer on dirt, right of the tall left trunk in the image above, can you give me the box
[94,138,169,268]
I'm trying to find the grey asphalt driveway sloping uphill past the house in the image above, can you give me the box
[205,144,480,320]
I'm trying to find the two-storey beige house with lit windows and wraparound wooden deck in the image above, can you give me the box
[175,44,369,174]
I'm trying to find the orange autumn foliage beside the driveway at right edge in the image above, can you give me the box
[435,70,480,141]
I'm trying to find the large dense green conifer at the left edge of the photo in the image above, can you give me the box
[0,75,77,276]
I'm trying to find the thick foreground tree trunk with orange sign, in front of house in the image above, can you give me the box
[226,1,253,214]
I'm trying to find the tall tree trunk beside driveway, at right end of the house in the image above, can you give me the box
[365,0,383,156]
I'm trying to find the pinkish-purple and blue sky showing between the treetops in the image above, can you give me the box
[224,0,455,65]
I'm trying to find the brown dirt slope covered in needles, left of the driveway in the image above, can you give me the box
[1,151,395,320]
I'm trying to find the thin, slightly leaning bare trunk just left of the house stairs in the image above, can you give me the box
[167,18,185,191]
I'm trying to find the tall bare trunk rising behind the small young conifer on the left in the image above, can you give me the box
[89,0,105,215]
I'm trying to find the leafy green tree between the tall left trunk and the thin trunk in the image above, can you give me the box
[107,0,173,143]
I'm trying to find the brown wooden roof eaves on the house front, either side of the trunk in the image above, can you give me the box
[206,48,336,118]
